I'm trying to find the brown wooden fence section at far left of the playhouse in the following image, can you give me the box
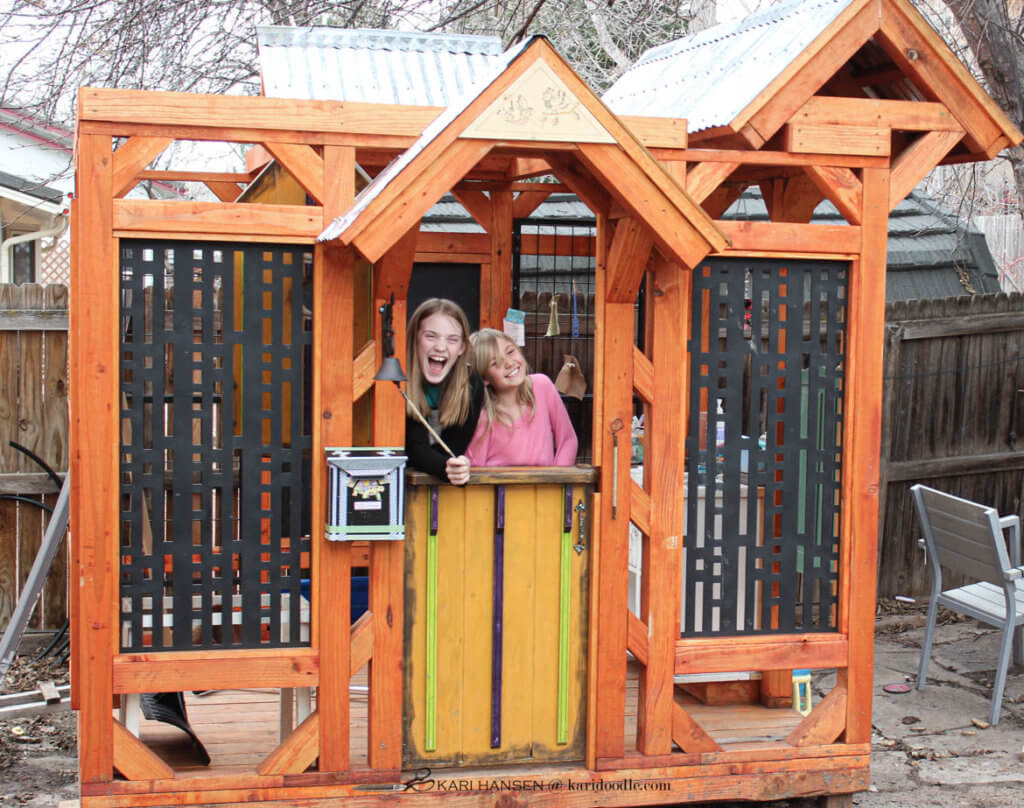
[0,284,69,629]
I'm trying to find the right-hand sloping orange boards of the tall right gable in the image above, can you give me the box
[878,0,1024,160]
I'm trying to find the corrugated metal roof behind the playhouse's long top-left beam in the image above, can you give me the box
[256,26,502,107]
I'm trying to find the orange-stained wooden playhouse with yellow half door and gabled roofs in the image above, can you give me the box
[71,0,1021,808]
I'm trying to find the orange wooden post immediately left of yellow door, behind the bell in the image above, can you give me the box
[367,222,420,772]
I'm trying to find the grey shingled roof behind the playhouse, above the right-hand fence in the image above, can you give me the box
[421,187,999,303]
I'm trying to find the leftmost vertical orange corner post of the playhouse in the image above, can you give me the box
[70,130,121,782]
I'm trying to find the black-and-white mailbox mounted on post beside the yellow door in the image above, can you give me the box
[325,446,406,542]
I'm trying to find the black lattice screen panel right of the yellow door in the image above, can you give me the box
[681,259,847,636]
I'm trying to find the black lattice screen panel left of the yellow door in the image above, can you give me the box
[120,241,312,651]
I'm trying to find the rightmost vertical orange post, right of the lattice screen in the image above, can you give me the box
[839,169,890,743]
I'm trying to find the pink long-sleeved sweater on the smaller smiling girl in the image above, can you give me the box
[466,373,580,466]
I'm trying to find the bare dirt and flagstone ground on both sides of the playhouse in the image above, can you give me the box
[0,601,1024,808]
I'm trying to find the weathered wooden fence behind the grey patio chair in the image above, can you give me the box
[879,294,1024,596]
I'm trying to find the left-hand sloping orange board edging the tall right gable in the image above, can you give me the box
[731,0,885,143]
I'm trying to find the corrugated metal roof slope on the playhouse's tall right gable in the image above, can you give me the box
[603,0,854,132]
